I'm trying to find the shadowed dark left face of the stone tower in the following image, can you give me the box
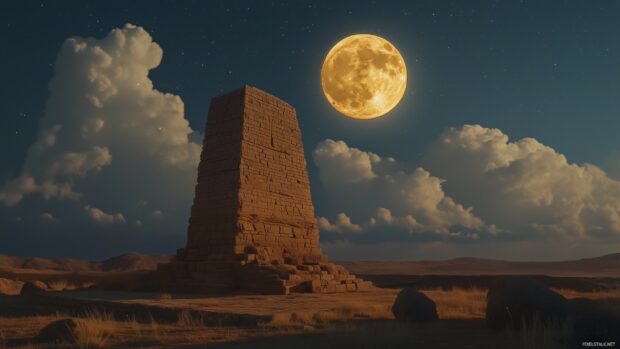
[185,90,245,260]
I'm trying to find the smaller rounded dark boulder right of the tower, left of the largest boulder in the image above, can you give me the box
[392,287,439,322]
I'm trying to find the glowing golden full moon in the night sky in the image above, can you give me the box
[321,34,407,119]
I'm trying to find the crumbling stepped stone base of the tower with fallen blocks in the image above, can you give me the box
[157,249,373,294]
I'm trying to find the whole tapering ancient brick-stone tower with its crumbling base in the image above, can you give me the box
[159,86,372,294]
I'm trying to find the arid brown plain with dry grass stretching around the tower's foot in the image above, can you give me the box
[0,251,620,349]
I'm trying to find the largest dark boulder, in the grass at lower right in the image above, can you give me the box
[486,276,567,330]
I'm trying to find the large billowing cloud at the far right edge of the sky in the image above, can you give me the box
[425,125,620,241]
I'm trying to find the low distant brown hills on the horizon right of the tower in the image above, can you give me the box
[338,253,620,277]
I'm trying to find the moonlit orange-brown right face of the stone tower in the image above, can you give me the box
[237,87,325,264]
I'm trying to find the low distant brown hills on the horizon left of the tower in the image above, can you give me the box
[0,253,170,272]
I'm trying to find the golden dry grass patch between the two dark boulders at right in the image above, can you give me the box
[421,288,487,319]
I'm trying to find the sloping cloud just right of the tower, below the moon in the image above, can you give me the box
[313,139,494,237]
